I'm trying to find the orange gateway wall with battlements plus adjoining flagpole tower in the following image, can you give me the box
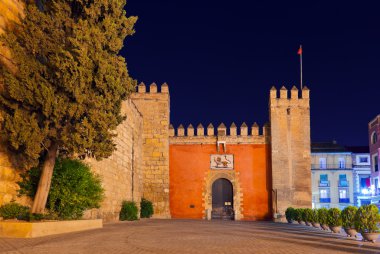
[169,87,311,220]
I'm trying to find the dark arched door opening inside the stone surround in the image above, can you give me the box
[211,178,234,220]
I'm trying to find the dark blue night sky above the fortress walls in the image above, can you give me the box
[122,0,380,145]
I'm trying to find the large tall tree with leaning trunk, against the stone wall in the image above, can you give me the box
[0,0,136,213]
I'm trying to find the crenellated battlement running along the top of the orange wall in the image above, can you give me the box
[169,122,270,144]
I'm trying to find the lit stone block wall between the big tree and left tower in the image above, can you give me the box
[85,99,143,221]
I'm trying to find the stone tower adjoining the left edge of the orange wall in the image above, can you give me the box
[131,83,170,218]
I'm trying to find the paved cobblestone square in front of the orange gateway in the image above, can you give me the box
[0,220,380,254]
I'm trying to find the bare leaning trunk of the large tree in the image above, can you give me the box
[32,143,58,213]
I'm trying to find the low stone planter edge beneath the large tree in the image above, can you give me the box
[0,219,103,238]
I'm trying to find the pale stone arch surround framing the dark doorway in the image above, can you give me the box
[203,170,243,220]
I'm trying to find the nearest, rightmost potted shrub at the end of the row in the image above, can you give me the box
[355,204,380,242]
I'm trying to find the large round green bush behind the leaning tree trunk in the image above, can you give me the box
[18,158,104,220]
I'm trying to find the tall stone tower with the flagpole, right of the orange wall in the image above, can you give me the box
[269,86,311,219]
